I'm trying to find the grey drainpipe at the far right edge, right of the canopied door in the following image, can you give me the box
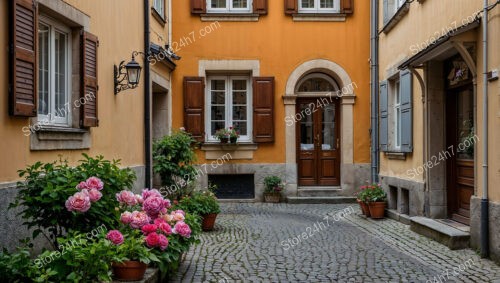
[481,0,489,258]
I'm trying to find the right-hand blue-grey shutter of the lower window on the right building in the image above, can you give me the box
[399,69,413,152]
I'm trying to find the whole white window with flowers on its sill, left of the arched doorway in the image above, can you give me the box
[206,76,252,141]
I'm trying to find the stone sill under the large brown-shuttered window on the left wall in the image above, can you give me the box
[30,126,91,150]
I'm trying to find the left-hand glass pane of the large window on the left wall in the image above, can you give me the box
[38,23,50,115]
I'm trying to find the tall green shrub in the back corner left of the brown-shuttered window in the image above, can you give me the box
[153,131,196,193]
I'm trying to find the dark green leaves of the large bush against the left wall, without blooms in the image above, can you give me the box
[9,154,136,248]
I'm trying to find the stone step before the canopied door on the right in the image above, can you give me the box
[410,216,470,250]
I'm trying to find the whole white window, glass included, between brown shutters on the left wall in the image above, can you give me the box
[38,16,71,126]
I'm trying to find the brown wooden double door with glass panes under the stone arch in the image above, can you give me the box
[296,98,340,186]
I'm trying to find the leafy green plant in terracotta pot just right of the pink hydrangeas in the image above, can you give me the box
[176,189,220,231]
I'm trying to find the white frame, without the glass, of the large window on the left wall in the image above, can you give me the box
[37,15,72,127]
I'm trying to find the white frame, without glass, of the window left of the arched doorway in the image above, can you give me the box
[205,75,253,142]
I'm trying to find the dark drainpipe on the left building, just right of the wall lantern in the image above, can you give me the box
[144,0,152,191]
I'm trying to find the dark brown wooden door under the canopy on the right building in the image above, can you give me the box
[446,87,478,225]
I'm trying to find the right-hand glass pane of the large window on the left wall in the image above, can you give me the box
[54,32,67,117]
